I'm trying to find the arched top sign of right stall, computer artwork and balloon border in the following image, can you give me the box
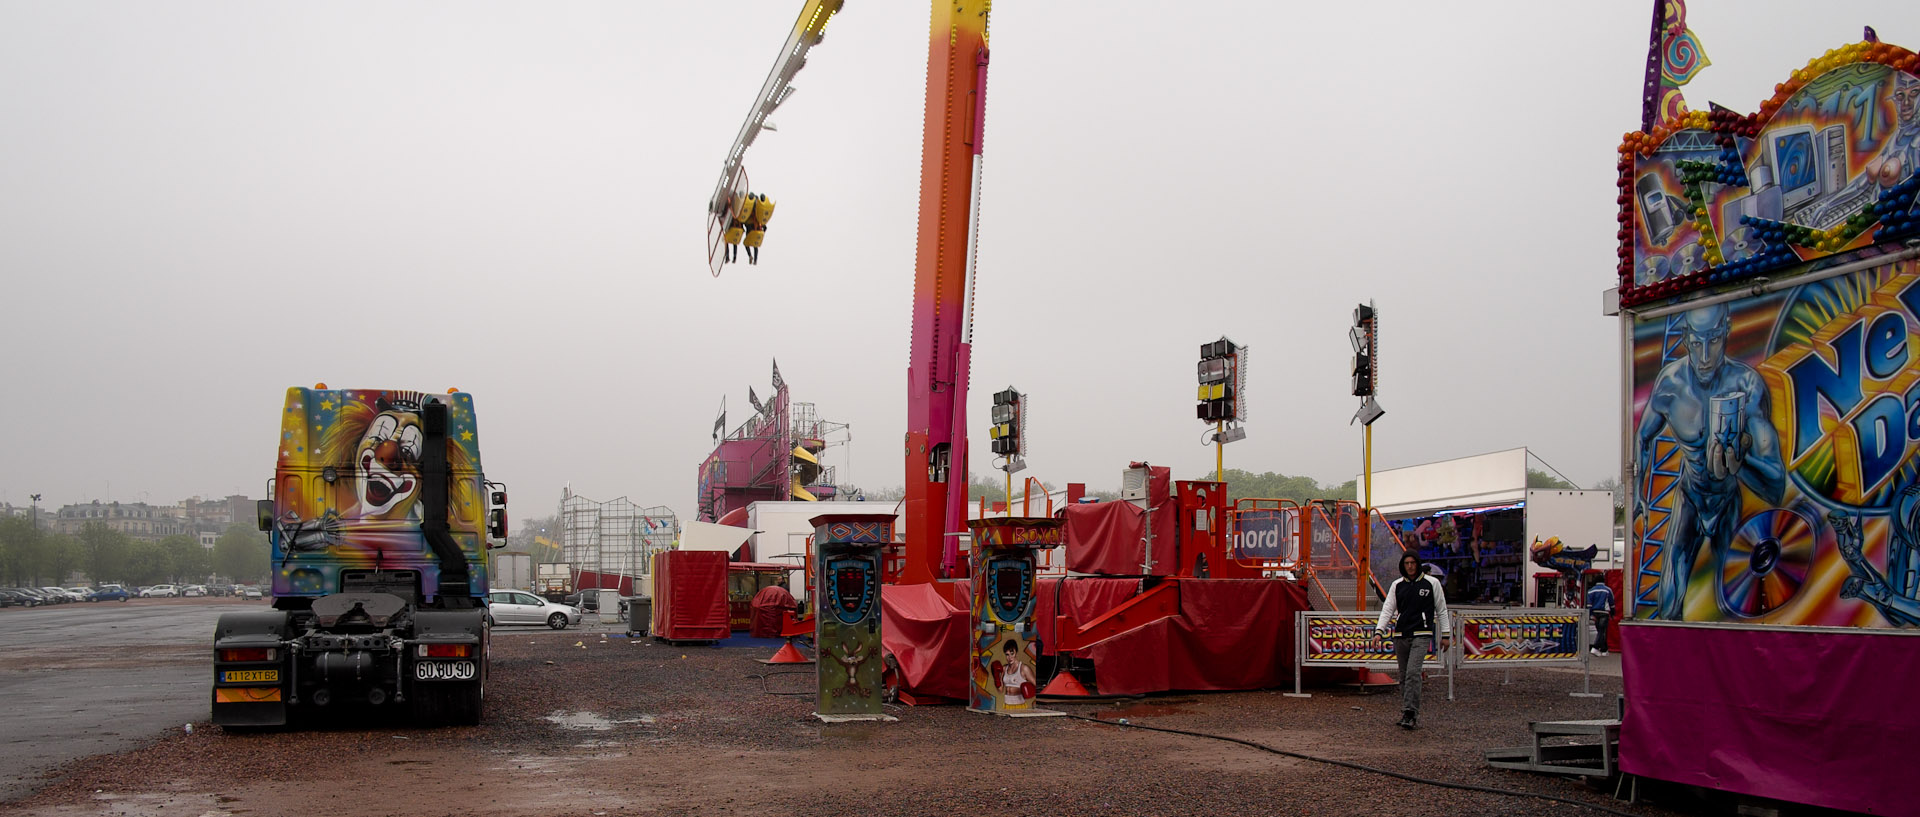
[1619,42,1920,305]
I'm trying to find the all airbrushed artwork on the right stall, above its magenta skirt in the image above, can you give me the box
[1622,48,1920,627]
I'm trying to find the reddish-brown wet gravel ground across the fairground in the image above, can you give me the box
[0,631,1712,817]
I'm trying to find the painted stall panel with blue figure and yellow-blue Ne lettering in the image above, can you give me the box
[1630,261,1920,627]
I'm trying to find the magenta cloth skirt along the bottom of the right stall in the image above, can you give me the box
[1620,621,1920,813]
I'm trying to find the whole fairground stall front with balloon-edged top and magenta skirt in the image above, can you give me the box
[1607,2,1920,813]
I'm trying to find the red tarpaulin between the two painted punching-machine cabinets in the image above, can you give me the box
[879,583,972,700]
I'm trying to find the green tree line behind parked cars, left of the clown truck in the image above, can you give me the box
[0,516,271,587]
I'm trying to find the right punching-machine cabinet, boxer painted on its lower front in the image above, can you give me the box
[968,518,1066,712]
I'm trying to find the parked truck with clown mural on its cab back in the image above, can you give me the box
[213,385,507,727]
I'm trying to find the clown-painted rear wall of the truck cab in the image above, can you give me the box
[271,387,488,596]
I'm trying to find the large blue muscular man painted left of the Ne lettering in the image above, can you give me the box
[1640,305,1786,621]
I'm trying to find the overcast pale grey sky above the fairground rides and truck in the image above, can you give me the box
[0,0,1896,518]
